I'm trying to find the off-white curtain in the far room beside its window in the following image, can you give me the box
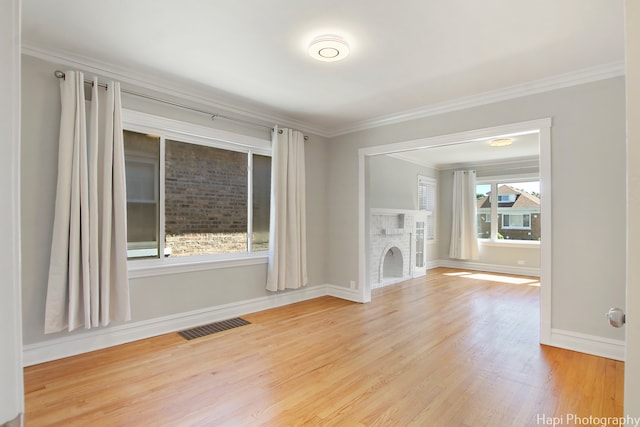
[449,171,478,260]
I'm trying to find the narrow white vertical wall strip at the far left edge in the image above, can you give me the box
[0,0,24,424]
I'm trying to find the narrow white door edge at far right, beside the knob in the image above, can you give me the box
[624,0,640,417]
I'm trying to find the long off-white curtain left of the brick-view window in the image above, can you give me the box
[44,71,131,333]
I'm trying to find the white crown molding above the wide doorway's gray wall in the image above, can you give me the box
[328,61,625,138]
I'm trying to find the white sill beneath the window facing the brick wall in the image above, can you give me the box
[127,252,268,279]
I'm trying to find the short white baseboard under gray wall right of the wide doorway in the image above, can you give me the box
[546,329,625,362]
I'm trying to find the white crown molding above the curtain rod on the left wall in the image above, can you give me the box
[21,42,328,138]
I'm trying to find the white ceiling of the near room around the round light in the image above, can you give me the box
[22,0,624,135]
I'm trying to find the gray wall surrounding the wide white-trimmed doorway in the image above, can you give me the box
[327,78,626,339]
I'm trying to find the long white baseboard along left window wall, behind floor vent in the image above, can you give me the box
[23,285,350,366]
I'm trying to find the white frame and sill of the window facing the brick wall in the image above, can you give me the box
[122,109,271,278]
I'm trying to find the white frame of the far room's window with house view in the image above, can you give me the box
[476,173,542,247]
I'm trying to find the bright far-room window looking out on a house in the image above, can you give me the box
[476,180,540,241]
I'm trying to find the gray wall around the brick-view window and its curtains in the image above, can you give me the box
[21,56,328,344]
